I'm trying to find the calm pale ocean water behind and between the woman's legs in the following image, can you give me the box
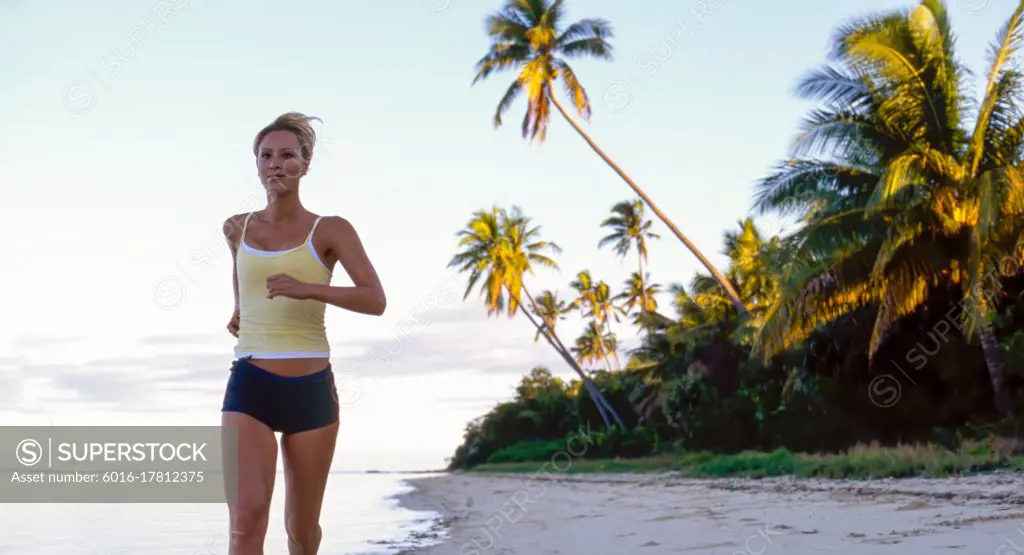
[0,471,444,555]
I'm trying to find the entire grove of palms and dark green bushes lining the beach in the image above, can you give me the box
[449,0,1024,469]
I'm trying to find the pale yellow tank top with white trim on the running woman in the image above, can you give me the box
[234,213,332,358]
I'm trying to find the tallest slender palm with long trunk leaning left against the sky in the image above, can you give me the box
[473,0,743,312]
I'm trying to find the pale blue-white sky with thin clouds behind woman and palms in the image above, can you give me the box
[0,0,1012,469]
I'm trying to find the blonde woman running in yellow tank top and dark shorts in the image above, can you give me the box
[221,113,387,555]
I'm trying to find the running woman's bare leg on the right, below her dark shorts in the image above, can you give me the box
[281,422,338,555]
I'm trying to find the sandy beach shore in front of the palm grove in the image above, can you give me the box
[399,471,1024,555]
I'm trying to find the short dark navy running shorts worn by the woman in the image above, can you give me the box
[220,357,338,434]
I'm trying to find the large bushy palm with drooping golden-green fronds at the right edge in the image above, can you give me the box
[758,0,1024,412]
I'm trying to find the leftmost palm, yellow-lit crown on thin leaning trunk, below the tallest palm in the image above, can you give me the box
[447,207,626,429]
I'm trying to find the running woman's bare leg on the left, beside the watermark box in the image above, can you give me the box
[221,412,278,555]
